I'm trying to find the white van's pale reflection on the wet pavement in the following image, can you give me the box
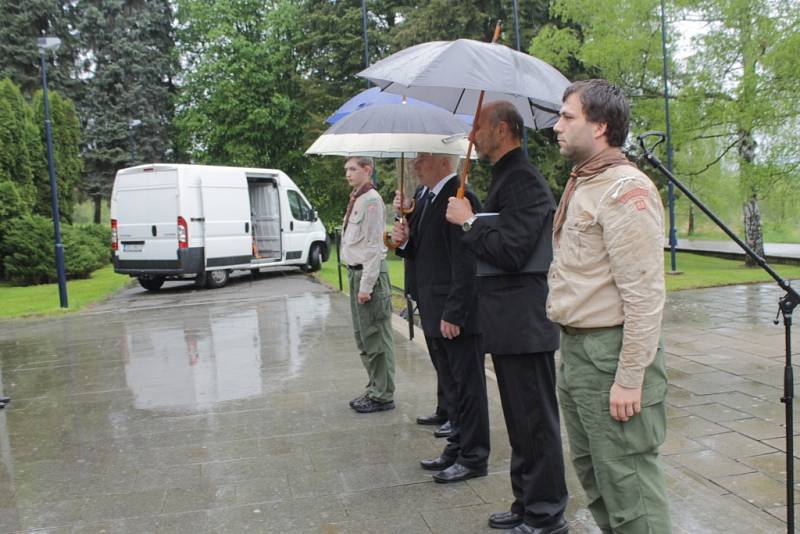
[119,294,330,410]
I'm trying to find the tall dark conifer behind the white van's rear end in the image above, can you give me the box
[76,0,178,222]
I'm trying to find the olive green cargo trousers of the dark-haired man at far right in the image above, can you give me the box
[557,327,672,534]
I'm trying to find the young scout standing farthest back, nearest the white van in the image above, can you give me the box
[341,157,394,413]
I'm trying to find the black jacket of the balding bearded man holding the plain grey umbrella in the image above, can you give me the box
[462,148,559,354]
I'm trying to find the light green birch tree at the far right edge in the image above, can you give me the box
[684,0,800,264]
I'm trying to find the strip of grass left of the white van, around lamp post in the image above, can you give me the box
[0,264,131,318]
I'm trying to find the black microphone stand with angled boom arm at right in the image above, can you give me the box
[637,132,800,534]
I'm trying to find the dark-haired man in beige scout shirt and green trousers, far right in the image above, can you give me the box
[547,80,671,534]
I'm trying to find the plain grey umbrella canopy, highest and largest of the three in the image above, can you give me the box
[358,39,570,128]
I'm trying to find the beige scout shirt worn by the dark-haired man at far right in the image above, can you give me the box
[547,166,665,387]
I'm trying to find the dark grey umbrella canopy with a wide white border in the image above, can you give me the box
[306,104,469,158]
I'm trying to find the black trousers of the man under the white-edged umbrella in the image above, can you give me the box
[430,334,490,469]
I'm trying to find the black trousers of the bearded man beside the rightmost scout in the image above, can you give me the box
[492,351,567,527]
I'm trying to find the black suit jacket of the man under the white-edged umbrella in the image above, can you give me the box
[402,176,480,337]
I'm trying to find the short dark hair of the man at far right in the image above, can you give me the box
[561,78,630,146]
